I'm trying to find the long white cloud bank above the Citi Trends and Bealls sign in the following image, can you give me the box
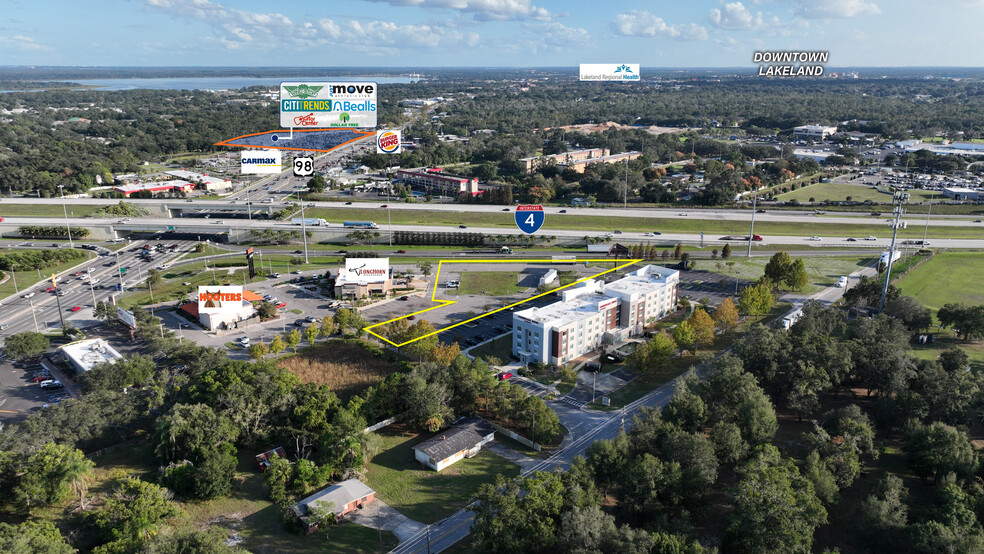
[144,0,479,54]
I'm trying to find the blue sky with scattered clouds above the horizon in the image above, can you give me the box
[0,0,984,68]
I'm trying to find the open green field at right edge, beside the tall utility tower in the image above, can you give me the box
[896,252,984,315]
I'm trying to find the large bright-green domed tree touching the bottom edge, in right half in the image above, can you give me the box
[725,445,827,553]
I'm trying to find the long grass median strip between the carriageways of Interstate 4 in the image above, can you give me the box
[307,204,980,238]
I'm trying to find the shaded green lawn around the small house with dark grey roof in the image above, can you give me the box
[365,425,519,523]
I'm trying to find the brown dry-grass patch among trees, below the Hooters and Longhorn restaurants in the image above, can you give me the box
[277,339,400,402]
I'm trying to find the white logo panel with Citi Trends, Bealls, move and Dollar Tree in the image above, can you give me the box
[280,81,378,129]
